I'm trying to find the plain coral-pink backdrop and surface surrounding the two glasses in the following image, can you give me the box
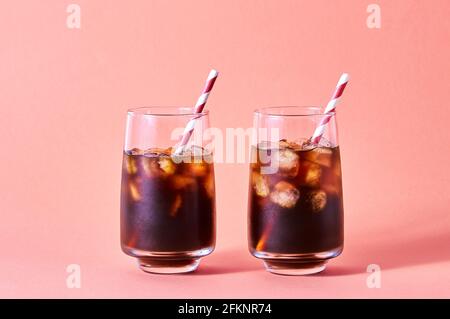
[0,0,450,298]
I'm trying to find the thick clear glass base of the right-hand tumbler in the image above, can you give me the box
[264,260,327,276]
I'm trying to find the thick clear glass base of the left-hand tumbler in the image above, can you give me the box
[138,257,200,274]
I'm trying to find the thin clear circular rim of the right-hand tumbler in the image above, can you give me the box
[253,105,336,117]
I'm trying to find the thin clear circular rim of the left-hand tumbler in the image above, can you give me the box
[127,105,209,117]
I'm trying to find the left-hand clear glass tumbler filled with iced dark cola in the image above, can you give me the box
[120,107,215,273]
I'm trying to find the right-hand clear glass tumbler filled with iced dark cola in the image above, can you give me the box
[248,106,344,275]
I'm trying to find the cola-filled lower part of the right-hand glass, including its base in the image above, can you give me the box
[249,140,343,274]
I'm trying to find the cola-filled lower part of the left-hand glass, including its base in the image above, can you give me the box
[121,149,215,273]
